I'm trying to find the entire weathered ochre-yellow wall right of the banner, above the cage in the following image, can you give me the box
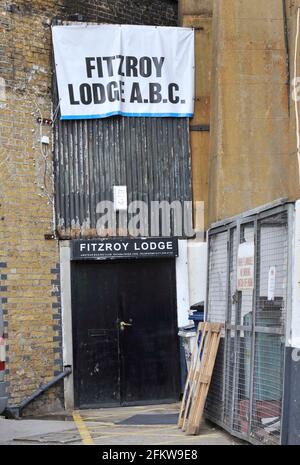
[179,0,300,225]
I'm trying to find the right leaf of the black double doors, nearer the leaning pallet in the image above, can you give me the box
[120,260,179,404]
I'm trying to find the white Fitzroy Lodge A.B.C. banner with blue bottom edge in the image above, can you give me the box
[52,25,194,119]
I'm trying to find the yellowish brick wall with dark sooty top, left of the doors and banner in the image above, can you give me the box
[0,0,177,413]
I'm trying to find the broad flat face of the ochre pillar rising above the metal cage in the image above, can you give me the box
[209,0,299,223]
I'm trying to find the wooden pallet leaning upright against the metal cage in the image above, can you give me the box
[178,322,223,435]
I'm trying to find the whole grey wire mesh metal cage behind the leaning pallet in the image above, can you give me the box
[205,204,293,444]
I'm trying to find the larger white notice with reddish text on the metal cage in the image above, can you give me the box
[237,242,254,291]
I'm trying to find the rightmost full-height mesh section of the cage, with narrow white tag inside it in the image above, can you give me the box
[251,212,288,444]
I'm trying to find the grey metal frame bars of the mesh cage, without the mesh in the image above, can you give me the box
[205,199,294,444]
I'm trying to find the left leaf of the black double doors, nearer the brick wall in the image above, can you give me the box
[72,262,120,407]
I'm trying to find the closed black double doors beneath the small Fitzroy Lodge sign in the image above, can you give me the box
[71,259,180,408]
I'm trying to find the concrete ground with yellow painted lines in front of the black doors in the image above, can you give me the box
[0,404,244,446]
